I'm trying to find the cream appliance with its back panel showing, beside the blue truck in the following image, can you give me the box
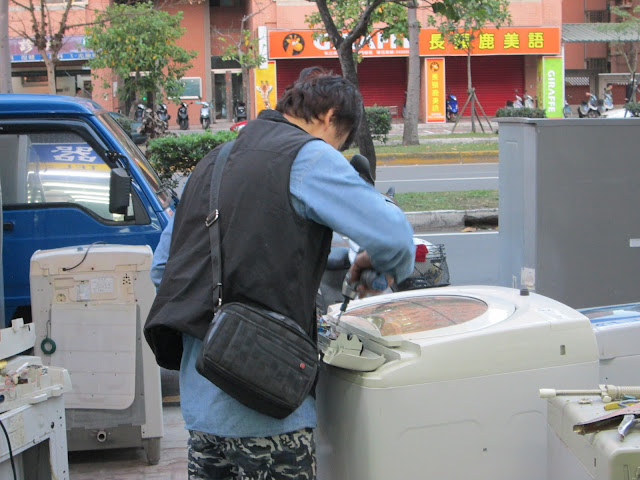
[30,244,163,464]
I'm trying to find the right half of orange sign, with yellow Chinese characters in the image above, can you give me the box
[420,27,561,56]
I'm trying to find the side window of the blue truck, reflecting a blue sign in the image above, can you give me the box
[0,131,133,222]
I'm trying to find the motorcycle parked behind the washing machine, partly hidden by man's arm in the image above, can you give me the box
[316,155,449,315]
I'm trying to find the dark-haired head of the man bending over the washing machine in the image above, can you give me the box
[276,67,364,149]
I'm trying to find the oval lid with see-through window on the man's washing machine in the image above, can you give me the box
[345,290,515,346]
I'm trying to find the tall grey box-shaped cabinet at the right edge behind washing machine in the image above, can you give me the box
[499,118,640,308]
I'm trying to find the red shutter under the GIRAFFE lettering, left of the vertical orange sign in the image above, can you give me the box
[276,57,407,111]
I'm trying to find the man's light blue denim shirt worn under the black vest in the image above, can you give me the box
[151,140,415,437]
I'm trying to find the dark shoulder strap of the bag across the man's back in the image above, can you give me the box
[204,140,235,308]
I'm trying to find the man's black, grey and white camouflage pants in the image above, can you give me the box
[189,428,316,480]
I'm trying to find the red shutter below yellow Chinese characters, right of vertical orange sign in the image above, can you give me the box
[445,55,524,117]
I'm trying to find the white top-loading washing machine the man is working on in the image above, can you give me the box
[317,287,598,480]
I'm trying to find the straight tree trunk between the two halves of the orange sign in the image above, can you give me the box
[402,1,420,145]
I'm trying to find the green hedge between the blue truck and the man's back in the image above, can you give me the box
[147,130,238,187]
